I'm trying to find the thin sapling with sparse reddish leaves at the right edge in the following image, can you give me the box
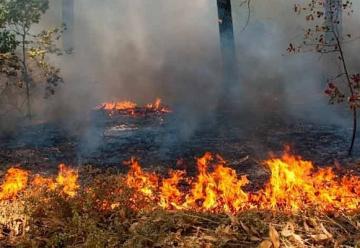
[288,0,360,155]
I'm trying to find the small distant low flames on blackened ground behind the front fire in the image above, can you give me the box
[95,98,171,116]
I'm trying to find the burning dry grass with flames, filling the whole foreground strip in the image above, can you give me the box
[0,148,360,247]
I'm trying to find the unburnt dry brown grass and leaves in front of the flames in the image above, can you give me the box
[0,168,360,248]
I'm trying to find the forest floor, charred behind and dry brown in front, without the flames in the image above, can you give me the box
[0,111,360,248]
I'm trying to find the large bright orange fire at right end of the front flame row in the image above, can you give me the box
[259,147,360,210]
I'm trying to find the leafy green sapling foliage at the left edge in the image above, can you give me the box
[0,0,65,118]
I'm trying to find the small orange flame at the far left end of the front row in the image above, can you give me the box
[0,168,29,200]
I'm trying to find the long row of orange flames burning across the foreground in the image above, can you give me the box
[0,150,360,213]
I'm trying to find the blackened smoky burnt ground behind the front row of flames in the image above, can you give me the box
[0,108,360,186]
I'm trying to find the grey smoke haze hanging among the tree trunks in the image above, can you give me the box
[3,0,360,153]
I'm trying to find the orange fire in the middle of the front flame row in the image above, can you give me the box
[127,153,249,212]
